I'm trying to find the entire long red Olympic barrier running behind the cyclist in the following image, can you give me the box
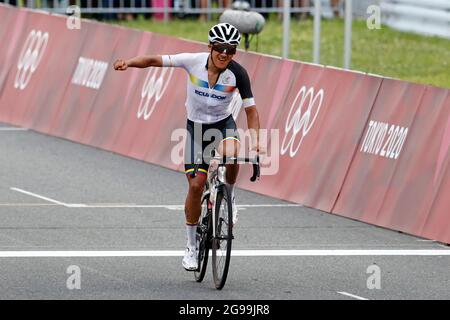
[0,5,450,243]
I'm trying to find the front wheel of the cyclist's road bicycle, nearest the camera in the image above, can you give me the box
[212,185,233,290]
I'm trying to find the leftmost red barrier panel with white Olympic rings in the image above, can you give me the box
[0,10,85,133]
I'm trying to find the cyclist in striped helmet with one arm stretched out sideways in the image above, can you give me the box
[114,23,260,271]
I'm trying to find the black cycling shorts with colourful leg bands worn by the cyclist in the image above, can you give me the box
[184,115,239,175]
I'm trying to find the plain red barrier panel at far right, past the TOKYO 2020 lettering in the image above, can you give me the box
[384,87,450,243]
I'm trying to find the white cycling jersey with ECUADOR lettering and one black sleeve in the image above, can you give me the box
[162,52,255,123]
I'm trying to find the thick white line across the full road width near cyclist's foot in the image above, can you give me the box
[0,250,450,258]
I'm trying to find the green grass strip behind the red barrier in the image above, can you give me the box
[114,16,450,88]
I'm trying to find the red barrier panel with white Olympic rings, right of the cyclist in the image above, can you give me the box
[237,64,381,211]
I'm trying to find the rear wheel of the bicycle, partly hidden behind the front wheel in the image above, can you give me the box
[194,195,211,282]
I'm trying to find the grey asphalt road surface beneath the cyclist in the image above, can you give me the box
[0,124,450,300]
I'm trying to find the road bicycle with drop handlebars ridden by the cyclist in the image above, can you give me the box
[194,153,260,290]
